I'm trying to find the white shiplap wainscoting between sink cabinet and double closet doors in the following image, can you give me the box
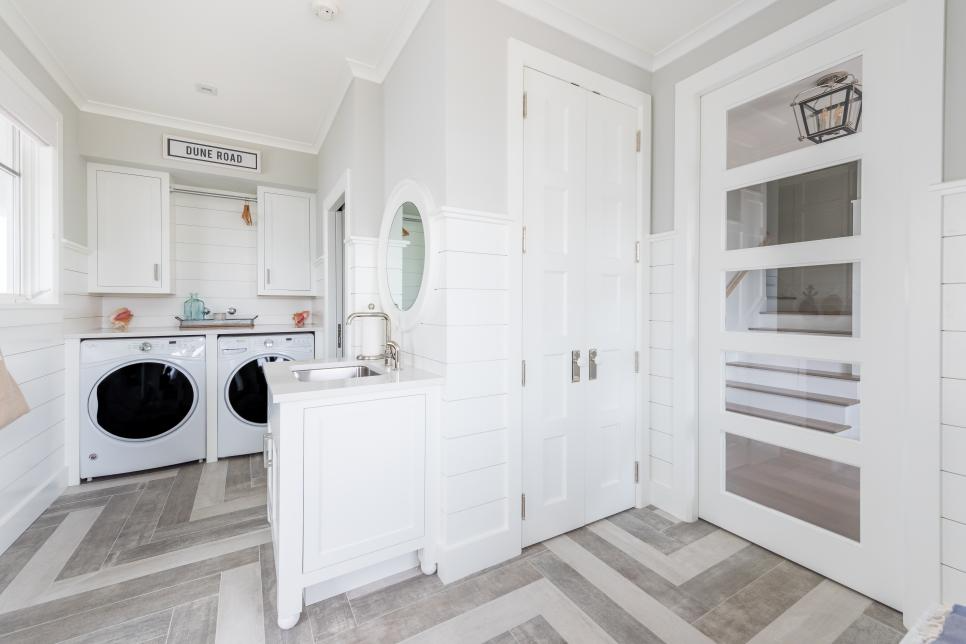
[403,207,520,582]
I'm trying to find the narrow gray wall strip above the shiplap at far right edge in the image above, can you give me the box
[943,0,966,181]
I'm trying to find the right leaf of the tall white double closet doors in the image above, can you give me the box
[584,94,637,523]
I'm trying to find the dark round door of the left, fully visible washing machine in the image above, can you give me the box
[88,361,198,441]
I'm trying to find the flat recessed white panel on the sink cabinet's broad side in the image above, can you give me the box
[303,395,426,572]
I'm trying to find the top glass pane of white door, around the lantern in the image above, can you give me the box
[728,56,862,168]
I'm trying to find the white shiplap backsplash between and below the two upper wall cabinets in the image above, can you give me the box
[102,193,312,330]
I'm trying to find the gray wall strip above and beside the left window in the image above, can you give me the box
[0,20,87,244]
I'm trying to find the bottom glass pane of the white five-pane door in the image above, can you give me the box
[725,434,860,541]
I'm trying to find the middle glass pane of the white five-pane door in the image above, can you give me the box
[724,264,860,336]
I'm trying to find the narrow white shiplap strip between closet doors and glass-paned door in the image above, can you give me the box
[647,234,675,512]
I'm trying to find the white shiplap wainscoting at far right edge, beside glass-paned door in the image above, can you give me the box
[941,186,966,604]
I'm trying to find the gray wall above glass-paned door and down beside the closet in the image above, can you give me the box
[651,0,840,233]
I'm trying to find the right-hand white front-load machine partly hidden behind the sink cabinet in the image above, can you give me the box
[218,333,315,458]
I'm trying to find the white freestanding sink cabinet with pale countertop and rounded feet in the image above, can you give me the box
[265,361,442,628]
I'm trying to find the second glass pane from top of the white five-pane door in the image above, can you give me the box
[726,161,860,250]
